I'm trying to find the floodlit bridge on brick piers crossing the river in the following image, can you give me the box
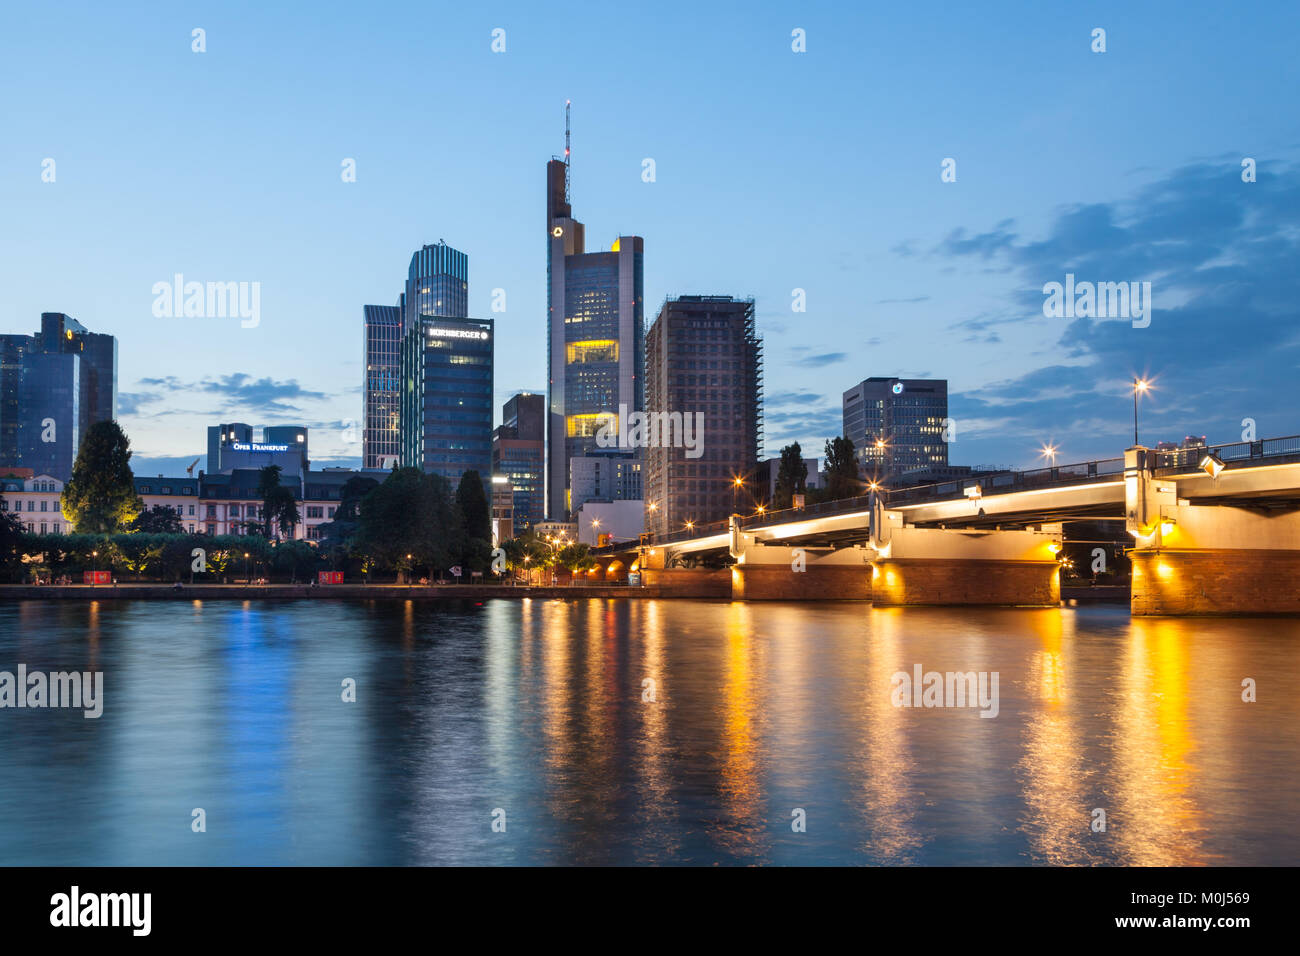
[593,436,1300,615]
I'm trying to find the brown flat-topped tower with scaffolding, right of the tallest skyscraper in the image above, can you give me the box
[645,295,763,535]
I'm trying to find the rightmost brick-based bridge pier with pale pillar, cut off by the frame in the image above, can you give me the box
[1125,447,1300,617]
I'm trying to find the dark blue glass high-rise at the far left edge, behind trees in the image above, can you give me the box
[0,312,117,481]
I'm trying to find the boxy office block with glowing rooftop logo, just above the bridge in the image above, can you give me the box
[844,377,948,479]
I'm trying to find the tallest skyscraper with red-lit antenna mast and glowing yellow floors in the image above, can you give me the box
[546,108,645,520]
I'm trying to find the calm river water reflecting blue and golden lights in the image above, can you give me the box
[0,598,1300,865]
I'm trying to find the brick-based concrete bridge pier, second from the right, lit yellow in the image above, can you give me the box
[871,510,1061,607]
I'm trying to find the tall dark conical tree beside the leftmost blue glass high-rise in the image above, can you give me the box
[60,420,144,533]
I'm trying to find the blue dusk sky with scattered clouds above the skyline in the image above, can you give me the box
[0,1,1300,475]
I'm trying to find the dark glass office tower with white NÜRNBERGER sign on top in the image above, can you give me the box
[400,315,494,493]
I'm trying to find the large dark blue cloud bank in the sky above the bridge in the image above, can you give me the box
[941,163,1300,454]
